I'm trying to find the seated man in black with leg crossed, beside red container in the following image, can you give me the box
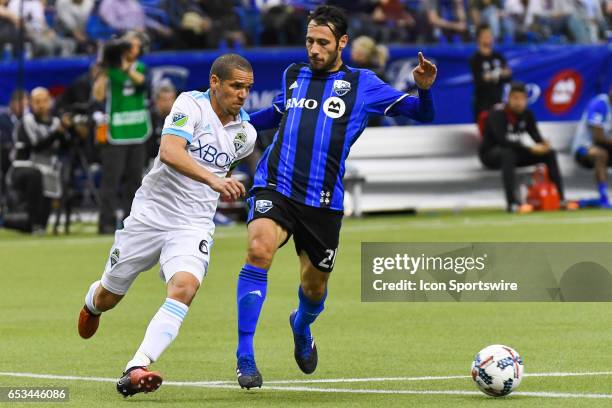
[479,82,565,213]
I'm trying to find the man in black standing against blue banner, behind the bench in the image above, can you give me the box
[470,25,512,122]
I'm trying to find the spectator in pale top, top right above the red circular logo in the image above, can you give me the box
[525,0,589,43]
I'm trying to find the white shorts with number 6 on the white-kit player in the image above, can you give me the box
[102,218,214,295]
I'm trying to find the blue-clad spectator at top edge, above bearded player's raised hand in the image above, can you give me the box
[422,0,468,41]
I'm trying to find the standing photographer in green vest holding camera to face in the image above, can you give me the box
[92,33,151,234]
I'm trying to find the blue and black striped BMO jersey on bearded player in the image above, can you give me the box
[253,64,430,211]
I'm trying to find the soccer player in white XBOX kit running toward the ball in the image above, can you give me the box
[78,54,256,397]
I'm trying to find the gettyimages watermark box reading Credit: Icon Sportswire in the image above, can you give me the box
[361,243,612,302]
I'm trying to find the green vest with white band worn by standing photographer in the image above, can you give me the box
[106,62,151,144]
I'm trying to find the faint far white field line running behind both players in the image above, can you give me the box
[0,212,612,248]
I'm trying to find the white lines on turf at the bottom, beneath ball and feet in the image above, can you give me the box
[0,371,612,399]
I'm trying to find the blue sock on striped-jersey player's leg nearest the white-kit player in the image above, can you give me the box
[236,264,268,357]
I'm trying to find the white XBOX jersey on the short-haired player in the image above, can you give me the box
[130,91,257,230]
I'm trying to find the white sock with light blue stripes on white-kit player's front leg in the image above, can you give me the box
[125,298,189,371]
